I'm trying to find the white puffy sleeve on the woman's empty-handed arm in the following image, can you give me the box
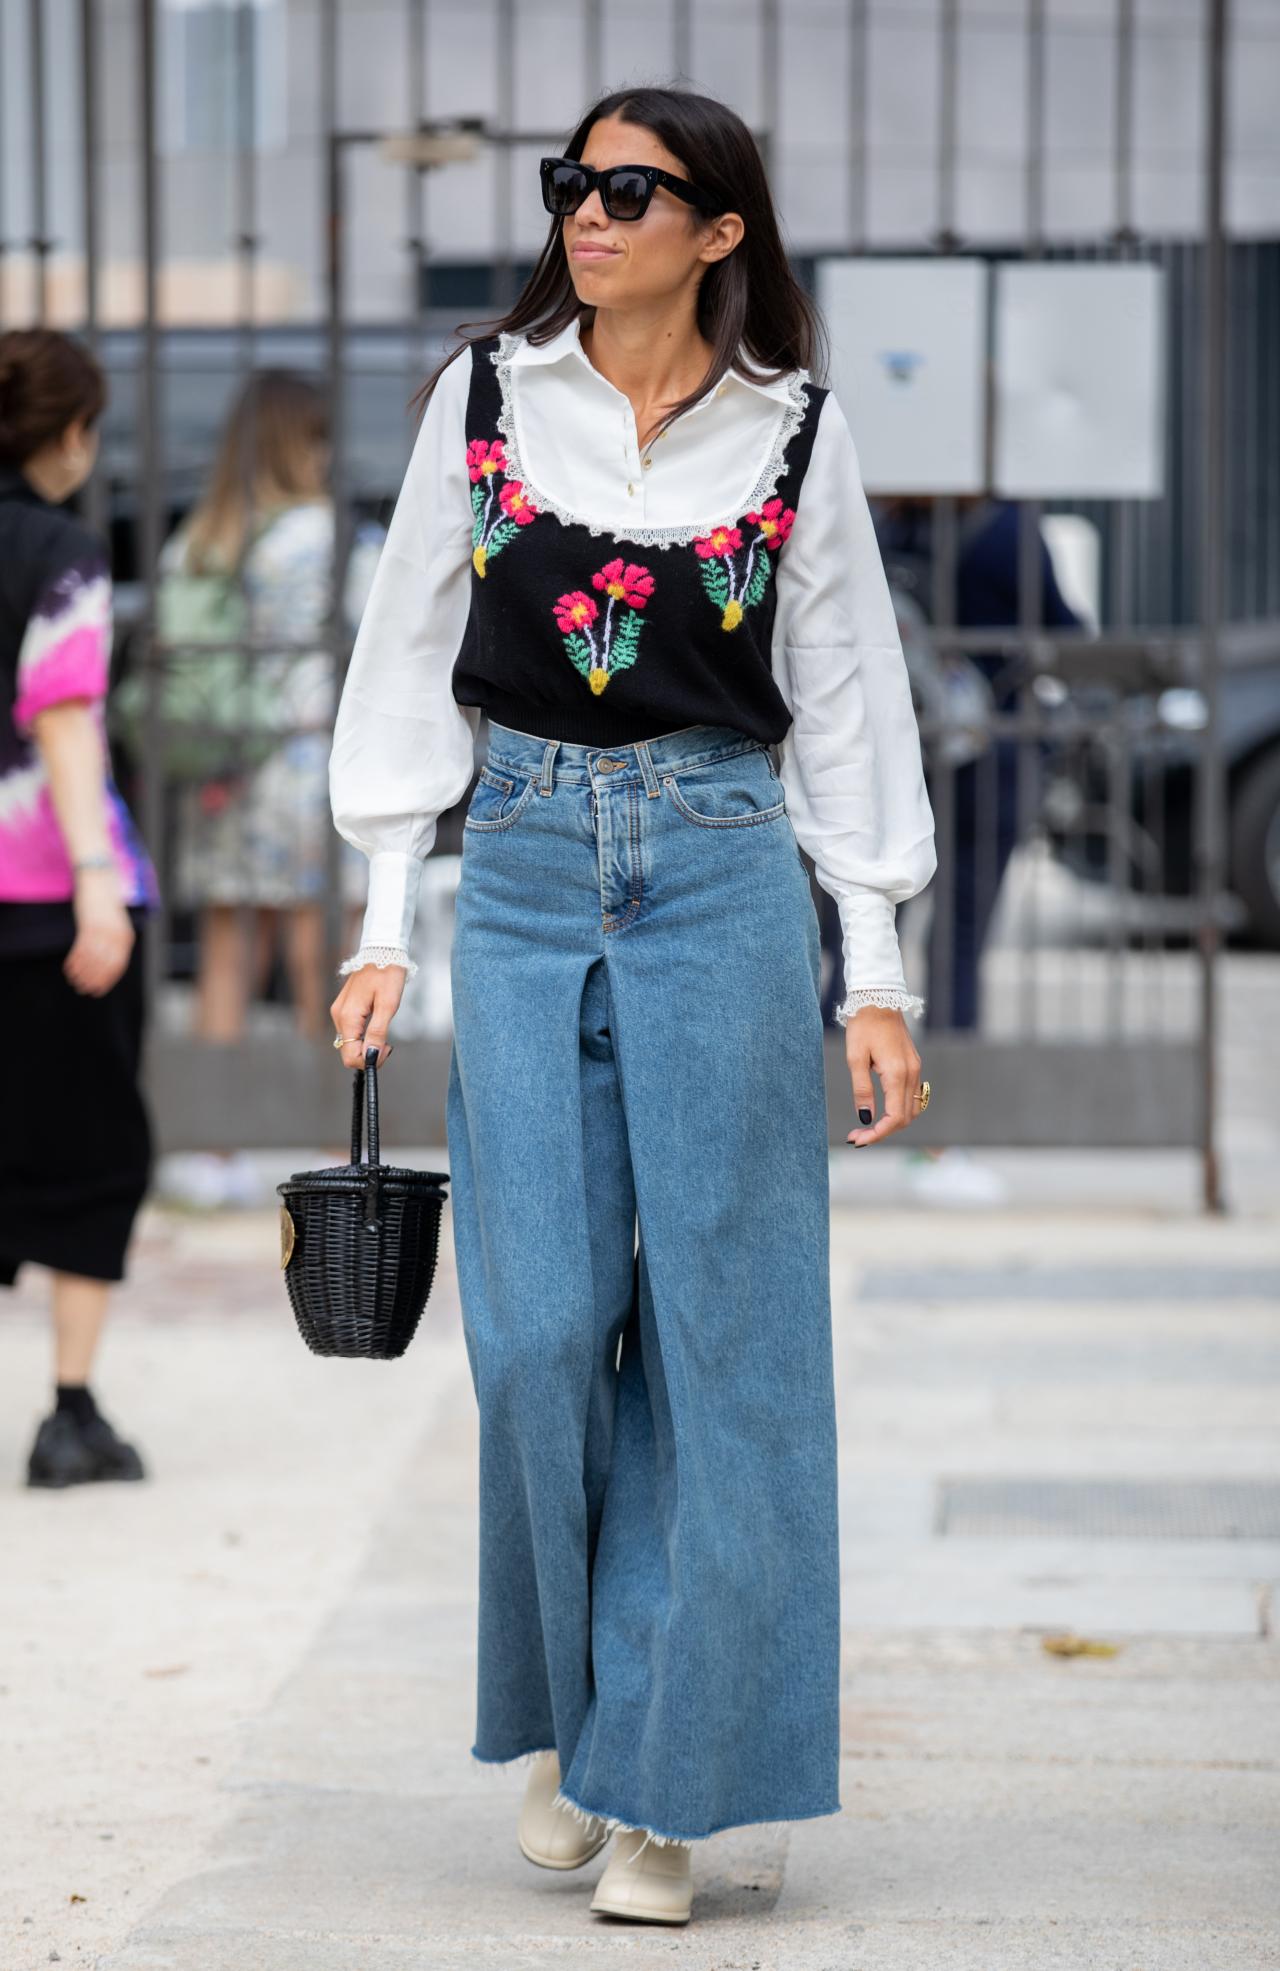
[771,390,937,1025]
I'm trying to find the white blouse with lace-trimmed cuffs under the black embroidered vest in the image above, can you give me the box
[329,319,937,1023]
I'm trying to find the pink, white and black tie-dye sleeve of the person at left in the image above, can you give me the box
[14,551,112,737]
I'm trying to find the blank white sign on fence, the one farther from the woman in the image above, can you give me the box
[994,262,1166,499]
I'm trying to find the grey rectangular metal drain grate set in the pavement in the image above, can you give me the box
[935,1478,1280,1539]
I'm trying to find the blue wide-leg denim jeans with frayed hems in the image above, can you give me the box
[448,723,840,1841]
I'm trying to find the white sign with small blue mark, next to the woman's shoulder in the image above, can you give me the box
[817,256,986,495]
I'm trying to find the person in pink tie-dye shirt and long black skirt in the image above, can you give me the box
[0,329,160,1486]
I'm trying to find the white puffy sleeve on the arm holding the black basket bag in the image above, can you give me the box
[329,349,479,974]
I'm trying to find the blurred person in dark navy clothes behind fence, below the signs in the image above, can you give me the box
[867,495,1083,1204]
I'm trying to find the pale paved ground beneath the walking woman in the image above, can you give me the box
[0,1153,1280,1971]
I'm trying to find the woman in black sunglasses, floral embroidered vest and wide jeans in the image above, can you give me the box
[329,89,935,1924]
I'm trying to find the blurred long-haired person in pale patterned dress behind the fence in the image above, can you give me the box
[158,371,383,1204]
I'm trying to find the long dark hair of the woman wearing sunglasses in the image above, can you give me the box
[412,87,826,436]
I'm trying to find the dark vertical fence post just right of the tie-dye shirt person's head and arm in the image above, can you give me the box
[136,0,172,1032]
